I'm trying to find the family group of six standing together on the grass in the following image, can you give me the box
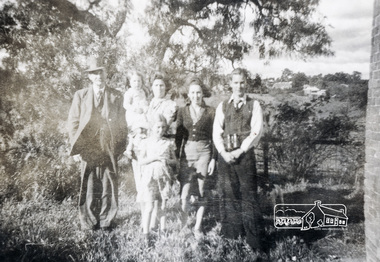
[68,56,263,249]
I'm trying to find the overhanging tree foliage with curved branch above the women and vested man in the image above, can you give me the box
[143,0,332,71]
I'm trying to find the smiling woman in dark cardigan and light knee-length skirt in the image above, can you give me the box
[176,77,216,237]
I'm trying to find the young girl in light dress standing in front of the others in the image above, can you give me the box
[139,114,176,245]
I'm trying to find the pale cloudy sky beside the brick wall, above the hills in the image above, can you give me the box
[243,0,374,79]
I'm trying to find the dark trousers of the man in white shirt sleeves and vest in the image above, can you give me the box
[218,149,260,250]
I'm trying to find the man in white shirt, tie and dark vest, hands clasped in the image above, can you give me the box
[213,68,263,250]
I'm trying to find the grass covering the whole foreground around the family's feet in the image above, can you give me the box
[0,176,364,262]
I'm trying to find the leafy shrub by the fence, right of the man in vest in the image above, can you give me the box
[264,102,358,182]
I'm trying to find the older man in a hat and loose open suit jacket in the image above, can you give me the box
[68,58,127,229]
